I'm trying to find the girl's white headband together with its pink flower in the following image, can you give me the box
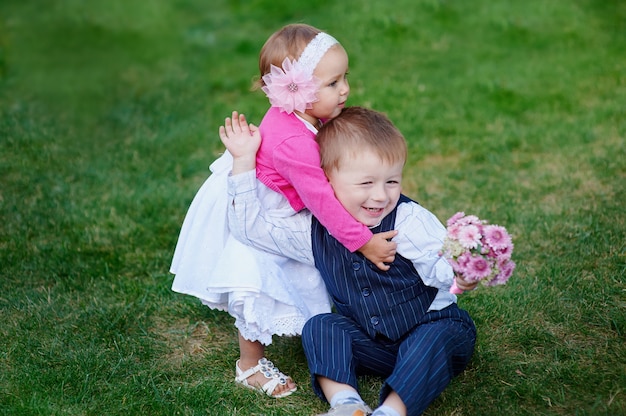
[261,32,339,114]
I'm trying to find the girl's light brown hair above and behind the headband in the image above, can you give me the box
[252,23,321,90]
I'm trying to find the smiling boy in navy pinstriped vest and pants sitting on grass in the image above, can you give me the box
[220,107,476,416]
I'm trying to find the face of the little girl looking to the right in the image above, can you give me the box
[298,44,350,126]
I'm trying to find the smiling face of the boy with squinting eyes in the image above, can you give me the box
[328,150,404,227]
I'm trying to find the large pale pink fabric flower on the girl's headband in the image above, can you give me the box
[261,58,319,114]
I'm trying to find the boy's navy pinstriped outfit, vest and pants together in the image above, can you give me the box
[302,196,476,415]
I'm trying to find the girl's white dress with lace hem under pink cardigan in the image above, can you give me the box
[170,152,330,345]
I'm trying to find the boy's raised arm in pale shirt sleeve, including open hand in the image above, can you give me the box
[219,112,314,265]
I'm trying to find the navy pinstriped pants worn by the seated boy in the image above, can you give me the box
[302,304,476,415]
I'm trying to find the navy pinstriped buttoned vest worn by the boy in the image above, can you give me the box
[311,195,437,341]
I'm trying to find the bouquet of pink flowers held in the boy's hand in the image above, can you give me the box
[440,212,515,294]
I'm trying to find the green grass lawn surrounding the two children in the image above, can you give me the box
[0,0,626,416]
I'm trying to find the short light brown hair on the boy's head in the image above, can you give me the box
[316,107,407,176]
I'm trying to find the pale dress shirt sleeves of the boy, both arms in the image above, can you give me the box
[228,171,456,310]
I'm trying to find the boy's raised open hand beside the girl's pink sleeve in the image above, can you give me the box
[219,111,261,174]
